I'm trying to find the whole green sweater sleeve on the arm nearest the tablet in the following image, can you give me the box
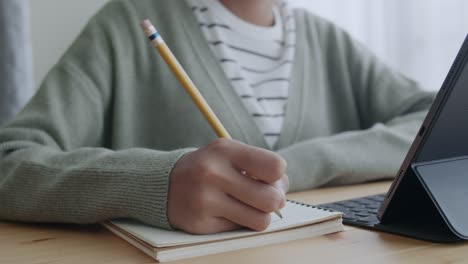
[278,17,434,191]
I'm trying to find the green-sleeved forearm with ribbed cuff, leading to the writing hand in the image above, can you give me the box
[0,135,194,228]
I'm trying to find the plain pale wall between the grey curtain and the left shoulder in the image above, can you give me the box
[30,0,109,86]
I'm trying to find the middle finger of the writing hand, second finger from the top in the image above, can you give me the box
[221,170,286,213]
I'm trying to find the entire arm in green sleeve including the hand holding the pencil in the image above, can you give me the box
[0,1,287,234]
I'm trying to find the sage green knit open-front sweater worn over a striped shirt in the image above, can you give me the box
[0,0,433,228]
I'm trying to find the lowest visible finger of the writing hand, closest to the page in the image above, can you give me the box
[217,195,271,231]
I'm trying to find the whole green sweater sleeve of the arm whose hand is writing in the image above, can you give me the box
[0,2,190,228]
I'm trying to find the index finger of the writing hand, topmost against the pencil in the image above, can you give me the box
[208,140,286,184]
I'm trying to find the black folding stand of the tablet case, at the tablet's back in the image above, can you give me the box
[375,157,468,243]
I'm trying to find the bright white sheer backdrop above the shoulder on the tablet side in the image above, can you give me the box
[292,0,468,90]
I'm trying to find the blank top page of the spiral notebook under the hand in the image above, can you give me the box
[111,202,341,248]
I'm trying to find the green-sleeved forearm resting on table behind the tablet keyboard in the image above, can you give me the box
[279,111,426,191]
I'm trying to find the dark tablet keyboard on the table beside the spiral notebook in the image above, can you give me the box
[320,194,385,227]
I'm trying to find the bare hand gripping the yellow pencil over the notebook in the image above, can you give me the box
[168,139,289,234]
